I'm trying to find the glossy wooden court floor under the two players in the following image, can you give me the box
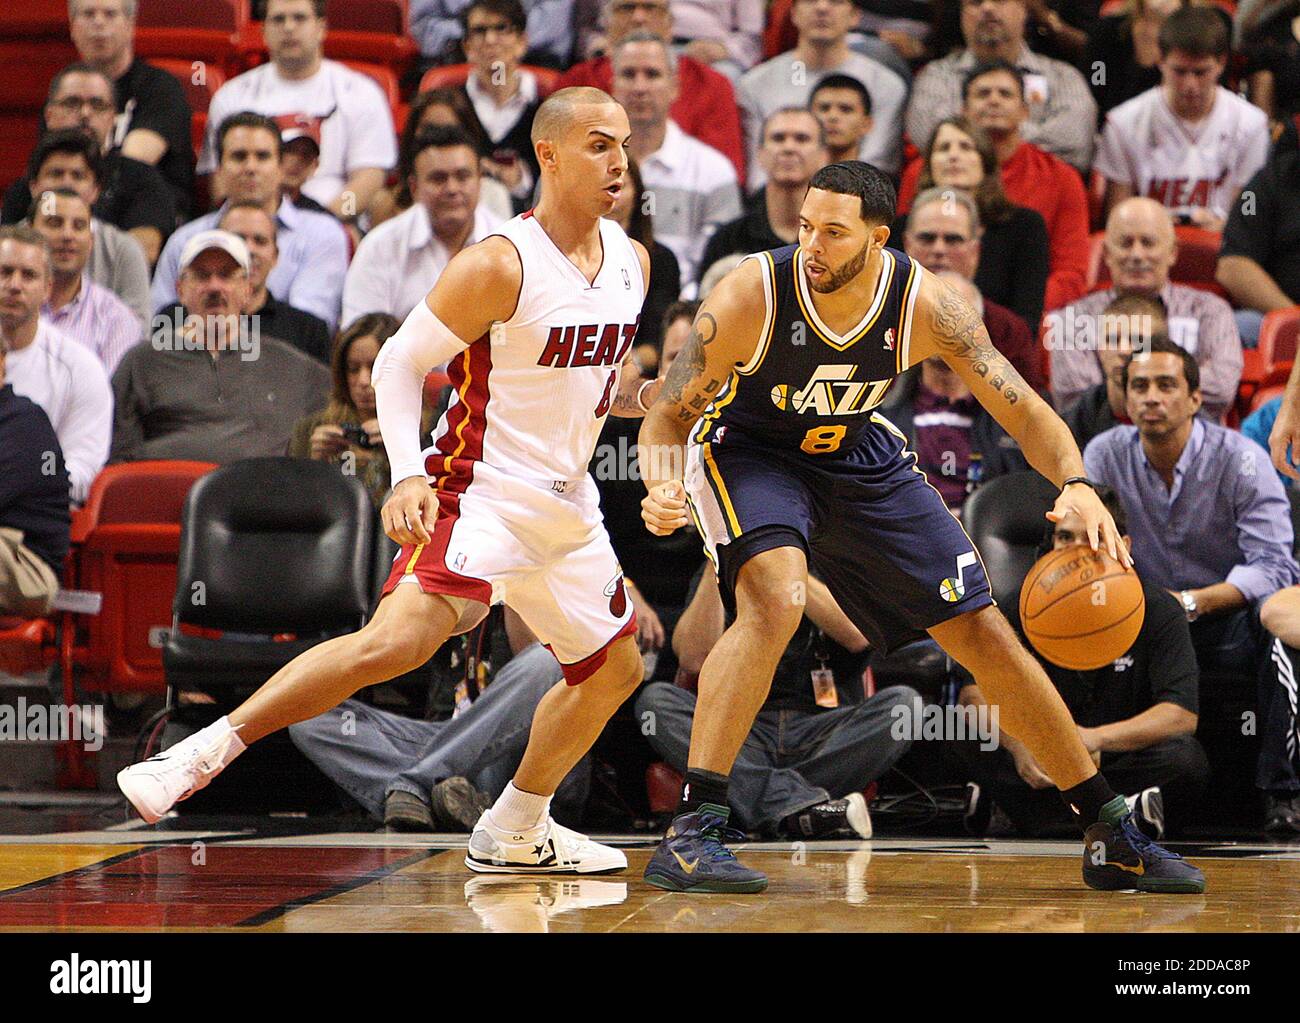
[0,828,1300,933]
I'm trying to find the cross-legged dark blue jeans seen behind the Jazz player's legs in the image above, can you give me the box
[636,682,919,832]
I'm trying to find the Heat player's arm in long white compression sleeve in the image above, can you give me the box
[372,237,523,543]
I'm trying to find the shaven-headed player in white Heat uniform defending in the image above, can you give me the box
[118,88,658,874]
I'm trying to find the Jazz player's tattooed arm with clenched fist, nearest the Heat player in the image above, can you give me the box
[637,260,763,536]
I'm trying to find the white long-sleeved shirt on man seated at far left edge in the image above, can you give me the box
[5,320,113,504]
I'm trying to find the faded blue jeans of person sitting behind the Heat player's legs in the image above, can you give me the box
[289,643,592,823]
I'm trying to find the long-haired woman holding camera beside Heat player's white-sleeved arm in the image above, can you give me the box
[289,312,433,508]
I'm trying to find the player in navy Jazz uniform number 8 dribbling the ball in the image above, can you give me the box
[641,160,1205,893]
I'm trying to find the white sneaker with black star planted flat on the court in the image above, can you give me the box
[465,810,628,874]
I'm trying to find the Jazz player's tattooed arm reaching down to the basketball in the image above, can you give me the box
[910,273,1132,565]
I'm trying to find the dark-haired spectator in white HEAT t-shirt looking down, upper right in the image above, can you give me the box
[1093,6,1269,231]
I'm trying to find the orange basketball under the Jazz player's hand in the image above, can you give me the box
[1021,547,1147,671]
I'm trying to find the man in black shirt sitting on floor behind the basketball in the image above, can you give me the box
[953,487,1210,838]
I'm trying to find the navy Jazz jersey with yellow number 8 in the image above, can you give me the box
[693,246,924,455]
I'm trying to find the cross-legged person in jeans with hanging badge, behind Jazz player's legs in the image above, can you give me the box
[636,565,920,838]
